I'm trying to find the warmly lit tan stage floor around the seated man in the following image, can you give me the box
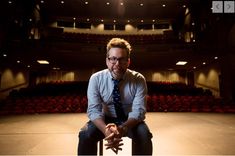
[0,112,235,156]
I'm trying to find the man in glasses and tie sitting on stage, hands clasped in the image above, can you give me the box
[78,38,152,155]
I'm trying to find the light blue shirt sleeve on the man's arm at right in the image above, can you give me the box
[128,75,147,121]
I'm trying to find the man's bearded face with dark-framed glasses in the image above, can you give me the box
[106,48,130,79]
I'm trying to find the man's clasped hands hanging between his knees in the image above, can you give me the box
[104,123,124,154]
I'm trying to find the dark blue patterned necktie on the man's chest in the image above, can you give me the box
[112,79,127,121]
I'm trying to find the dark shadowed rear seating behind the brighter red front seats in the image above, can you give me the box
[10,81,212,97]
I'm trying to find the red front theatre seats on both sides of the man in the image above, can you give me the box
[0,94,235,115]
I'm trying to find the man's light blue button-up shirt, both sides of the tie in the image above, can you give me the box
[87,69,147,121]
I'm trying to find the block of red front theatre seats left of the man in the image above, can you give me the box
[0,95,87,114]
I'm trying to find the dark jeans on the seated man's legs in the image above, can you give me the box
[78,121,153,156]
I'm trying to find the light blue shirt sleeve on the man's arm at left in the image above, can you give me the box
[87,75,104,121]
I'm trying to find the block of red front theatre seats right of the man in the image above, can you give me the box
[147,94,235,113]
